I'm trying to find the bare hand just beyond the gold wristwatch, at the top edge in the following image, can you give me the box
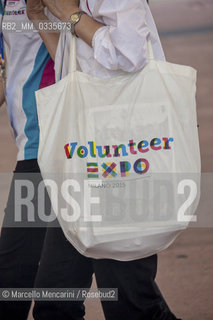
[42,0,80,20]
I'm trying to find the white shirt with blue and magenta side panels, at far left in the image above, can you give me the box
[0,0,55,160]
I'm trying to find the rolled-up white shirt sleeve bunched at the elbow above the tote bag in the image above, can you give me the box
[91,0,150,72]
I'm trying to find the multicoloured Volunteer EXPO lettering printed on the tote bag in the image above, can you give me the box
[64,137,174,179]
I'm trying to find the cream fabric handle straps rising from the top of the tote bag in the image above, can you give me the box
[69,34,155,73]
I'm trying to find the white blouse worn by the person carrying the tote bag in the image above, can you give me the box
[55,0,165,81]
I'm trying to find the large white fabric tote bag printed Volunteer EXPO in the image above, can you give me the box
[36,38,200,261]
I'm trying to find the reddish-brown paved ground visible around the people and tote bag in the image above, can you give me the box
[0,0,213,320]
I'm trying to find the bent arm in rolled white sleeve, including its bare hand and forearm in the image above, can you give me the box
[43,0,151,72]
